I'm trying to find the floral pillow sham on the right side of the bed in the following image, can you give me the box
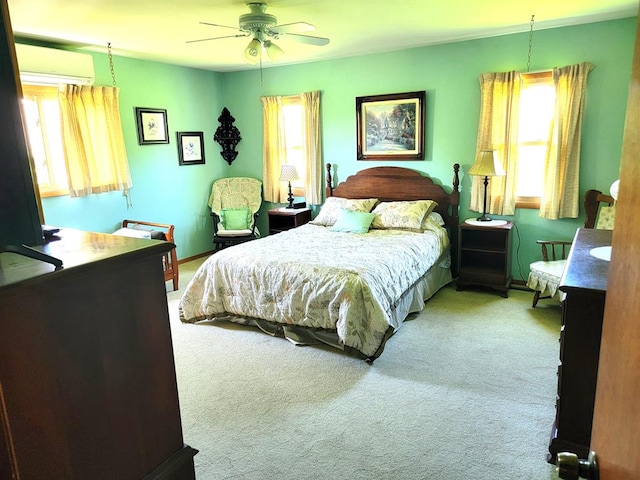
[371,200,438,231]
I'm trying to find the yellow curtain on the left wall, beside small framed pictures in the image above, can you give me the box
[58,85,133,204]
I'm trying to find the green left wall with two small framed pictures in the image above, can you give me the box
[42,54,229,258]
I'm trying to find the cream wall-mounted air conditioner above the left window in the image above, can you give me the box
[16,43,95,85]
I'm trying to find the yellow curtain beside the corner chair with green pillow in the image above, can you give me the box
[261,97,287,203]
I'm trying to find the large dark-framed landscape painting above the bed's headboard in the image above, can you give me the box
[356,91,426,160]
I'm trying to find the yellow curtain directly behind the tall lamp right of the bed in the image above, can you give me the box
[469,72,522,215]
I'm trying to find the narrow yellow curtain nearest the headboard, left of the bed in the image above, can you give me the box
[300,91,322,205]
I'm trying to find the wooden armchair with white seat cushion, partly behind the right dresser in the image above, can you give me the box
[527,190,615,308]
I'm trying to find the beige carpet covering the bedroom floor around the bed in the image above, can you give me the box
[168,260,560,480]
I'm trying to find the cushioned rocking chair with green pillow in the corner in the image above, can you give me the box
[209,177,262,251]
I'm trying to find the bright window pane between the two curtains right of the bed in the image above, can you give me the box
[516,71,555,208]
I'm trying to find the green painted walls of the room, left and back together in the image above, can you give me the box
[43,18,636,278]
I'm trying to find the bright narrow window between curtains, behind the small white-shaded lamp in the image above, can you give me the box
[282,96,307,196]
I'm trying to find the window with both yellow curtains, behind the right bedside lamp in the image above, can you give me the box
[469,62,593,220]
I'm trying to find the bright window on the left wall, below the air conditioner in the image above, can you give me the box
[22,85,69,197]
